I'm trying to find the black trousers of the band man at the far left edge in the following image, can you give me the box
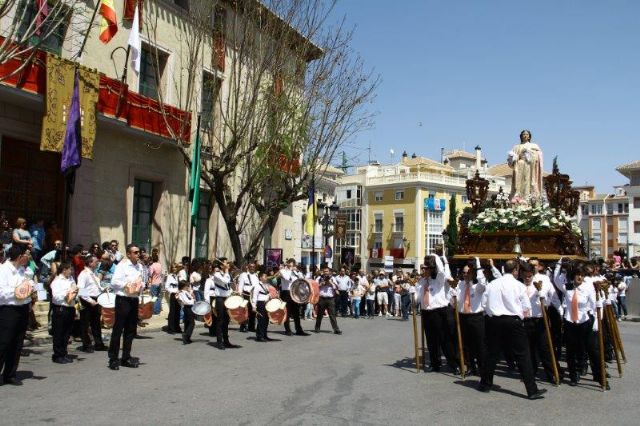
[0,305,30,379]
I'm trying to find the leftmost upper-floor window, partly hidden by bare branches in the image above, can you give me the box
[16,1,71,55]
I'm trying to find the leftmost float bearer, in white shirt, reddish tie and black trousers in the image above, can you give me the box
[416,255,458,372]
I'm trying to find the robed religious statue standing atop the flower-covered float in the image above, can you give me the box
[507,130,543,203]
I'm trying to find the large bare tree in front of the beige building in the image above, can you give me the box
[146,0,379,263]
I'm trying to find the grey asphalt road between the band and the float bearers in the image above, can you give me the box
[0,318,640,425]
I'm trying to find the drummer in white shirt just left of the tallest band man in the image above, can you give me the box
[78,255,107,353]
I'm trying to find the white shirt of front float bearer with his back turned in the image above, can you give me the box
[483,274,531,319]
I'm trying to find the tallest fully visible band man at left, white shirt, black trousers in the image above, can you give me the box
[109,244,142,370]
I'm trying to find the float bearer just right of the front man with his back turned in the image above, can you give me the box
[521,263,561,384]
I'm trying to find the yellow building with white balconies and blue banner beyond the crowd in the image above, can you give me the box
[336,148,504,270]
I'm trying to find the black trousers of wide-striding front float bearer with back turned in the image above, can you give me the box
[480,316,538,395]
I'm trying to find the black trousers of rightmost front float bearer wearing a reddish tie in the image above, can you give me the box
[564,317,600,381]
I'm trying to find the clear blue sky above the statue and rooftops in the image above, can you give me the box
[333,0,640,192]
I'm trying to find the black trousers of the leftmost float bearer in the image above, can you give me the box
[420,306,458,368]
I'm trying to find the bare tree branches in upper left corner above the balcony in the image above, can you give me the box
[0,0,80,81]
